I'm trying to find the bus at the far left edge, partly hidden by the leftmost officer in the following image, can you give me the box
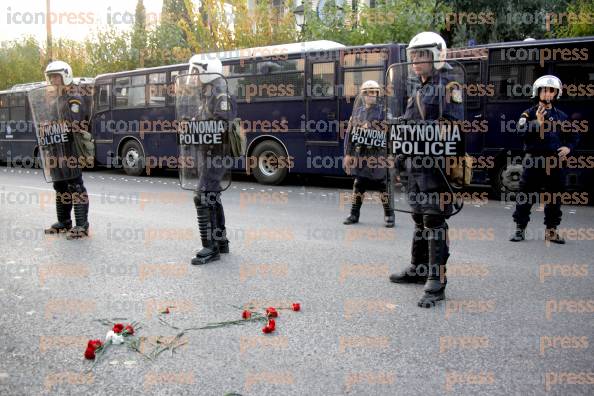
[0,77,93,168]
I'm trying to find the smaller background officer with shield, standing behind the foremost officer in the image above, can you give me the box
[343,80,394,228]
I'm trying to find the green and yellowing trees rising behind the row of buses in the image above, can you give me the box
[0,0,594,89]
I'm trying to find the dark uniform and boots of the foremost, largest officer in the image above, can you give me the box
[390,64,464,307]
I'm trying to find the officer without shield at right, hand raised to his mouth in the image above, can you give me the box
[510,75,578,244]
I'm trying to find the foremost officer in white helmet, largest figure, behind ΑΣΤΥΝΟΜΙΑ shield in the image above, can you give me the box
[390,32,464,308]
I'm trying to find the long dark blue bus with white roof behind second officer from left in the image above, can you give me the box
[92,40,405,184]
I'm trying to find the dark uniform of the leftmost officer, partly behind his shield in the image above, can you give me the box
[46,93,89,238]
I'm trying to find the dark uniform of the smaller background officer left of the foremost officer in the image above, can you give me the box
[344,104,394,227]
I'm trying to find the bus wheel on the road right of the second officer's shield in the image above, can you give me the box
[252,140,289,184]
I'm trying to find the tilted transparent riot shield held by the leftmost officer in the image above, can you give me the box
[28,85,82,183]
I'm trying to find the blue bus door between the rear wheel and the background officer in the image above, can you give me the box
[304,57,342,167]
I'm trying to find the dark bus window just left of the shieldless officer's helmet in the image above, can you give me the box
[489,64,545,101]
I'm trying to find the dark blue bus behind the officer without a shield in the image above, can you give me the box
[449,37,594,193]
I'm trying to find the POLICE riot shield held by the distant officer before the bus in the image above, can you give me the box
[344,92,388,180]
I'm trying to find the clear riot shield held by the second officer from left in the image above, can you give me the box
[175,73,233,192]
